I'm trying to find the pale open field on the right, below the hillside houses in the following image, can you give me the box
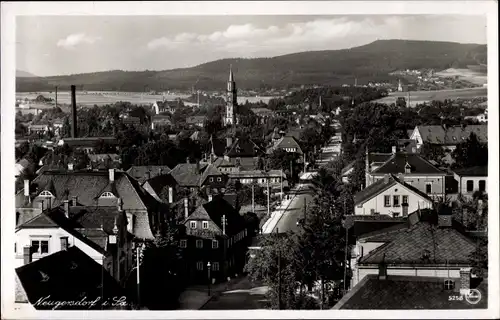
[374,88,488,106]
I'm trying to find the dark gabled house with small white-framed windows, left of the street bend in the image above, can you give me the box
[180,197,248,283]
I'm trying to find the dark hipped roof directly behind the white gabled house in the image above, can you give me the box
[371,152,444,175]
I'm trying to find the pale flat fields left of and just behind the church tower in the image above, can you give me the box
[16,91,273,109]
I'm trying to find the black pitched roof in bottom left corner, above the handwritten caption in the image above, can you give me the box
[16,246,126,310]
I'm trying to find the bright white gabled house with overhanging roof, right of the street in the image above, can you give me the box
[354,174,433,217]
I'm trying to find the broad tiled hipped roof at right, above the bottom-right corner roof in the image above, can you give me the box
[358,221,476,265]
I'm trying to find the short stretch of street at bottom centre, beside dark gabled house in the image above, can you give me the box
[200,277,267,310]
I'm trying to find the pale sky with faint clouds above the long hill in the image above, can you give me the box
[16,15,487,76]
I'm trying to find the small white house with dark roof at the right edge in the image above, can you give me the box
[453,166,488,198]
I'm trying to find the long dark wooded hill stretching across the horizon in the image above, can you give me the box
[16,40,486,92]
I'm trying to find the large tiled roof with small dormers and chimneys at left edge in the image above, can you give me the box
[15,169,168,240]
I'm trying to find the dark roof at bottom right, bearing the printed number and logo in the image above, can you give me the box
[333,275,488,310]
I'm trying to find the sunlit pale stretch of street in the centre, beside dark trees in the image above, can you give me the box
[273,184,313,233]
